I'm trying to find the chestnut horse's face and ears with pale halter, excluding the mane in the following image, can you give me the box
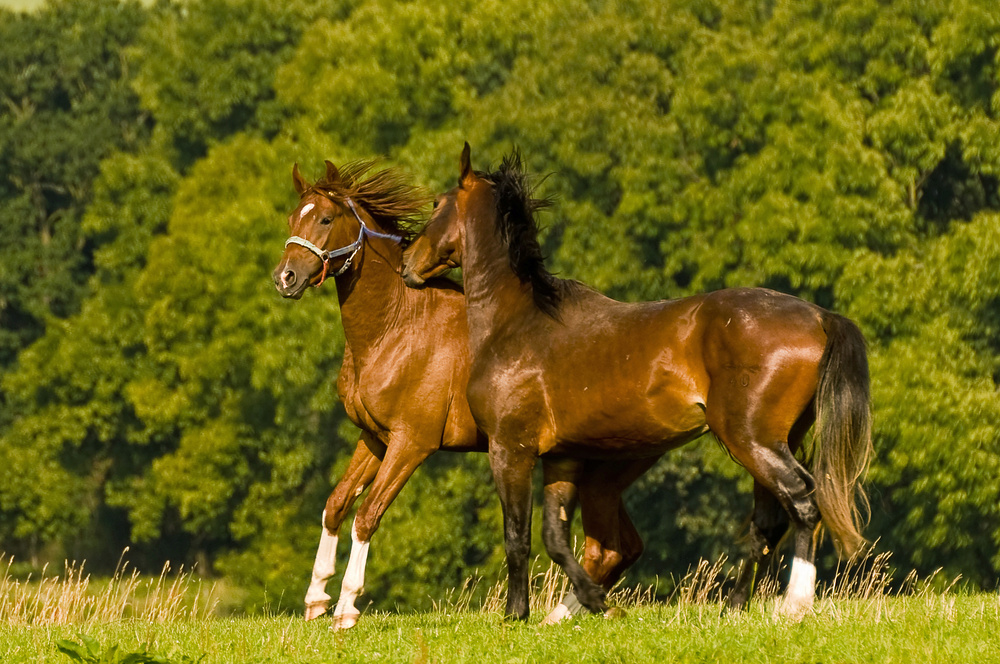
[273,161,359,299]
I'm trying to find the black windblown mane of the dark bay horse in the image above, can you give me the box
[487,148,562,318]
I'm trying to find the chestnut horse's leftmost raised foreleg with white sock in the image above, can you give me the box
[305,438,381,620]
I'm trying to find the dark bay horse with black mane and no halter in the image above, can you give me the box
[403,144,871,619]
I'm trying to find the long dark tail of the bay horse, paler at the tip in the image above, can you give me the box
[813,313,872,556]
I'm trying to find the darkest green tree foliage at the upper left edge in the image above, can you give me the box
[0,0,148,368]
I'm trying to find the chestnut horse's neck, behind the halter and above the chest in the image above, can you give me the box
[337,237,405,358]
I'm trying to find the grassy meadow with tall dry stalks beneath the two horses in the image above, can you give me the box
[0,557,1000,664]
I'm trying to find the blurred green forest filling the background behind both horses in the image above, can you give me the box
[0,0,1000,610]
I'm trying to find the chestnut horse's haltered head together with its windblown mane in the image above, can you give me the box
[272,161,424,299]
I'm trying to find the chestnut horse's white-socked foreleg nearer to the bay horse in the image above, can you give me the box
[331,442,437,629]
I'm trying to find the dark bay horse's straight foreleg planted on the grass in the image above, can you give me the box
[490,440,535,620]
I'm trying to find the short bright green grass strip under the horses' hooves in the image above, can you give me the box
[0,593,1000,664]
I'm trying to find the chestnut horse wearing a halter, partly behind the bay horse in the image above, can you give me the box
[273,162,656,629]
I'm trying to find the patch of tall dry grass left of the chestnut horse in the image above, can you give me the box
[0,549,219,625]
